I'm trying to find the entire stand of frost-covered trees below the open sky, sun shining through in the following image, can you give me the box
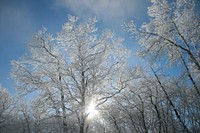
[0,0,200,133]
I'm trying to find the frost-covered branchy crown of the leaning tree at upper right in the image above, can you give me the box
[124,0,200,96]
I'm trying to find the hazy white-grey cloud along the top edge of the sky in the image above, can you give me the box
[55,0,149,21]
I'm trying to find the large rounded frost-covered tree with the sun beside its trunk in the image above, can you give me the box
[12,16,129,133]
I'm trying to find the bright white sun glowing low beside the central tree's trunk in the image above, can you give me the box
[86,102,99,119]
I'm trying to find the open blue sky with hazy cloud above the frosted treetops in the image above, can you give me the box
[0,0,150,93]
